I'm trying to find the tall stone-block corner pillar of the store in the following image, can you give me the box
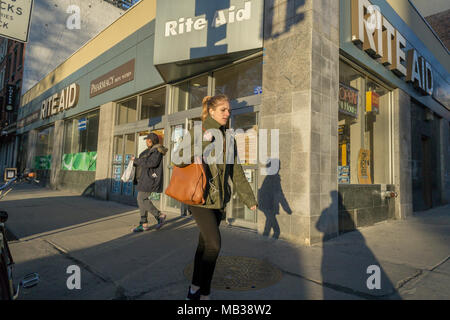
[258,0,339,245]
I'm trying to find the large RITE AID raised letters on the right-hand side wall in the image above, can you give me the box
[352,0,434,95]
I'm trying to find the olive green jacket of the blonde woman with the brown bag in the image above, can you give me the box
[174,116,257,209]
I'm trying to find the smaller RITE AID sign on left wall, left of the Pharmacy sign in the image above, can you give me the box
[40,83,80,119]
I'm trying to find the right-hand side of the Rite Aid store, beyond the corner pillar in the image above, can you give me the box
[338,0,450,231]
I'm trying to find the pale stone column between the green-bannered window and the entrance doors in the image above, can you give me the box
[95,102,115,200]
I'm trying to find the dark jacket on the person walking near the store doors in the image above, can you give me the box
[134,144,167,193]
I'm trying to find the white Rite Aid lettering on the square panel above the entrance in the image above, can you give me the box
[164,1,252,37]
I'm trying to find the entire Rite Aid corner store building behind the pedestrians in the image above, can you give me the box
[14,0,450,245]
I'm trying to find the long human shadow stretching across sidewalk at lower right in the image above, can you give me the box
[316,191,401,300]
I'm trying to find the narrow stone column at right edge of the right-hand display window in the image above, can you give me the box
[393,89,413,219]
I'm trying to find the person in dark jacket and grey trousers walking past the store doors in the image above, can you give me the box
[131,132,167,232]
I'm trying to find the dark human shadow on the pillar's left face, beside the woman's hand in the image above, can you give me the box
[258,159,292,239]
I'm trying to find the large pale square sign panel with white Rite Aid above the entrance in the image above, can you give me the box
[154,0,264,65]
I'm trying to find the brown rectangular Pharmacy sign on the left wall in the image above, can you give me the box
[90,59,134,98]
